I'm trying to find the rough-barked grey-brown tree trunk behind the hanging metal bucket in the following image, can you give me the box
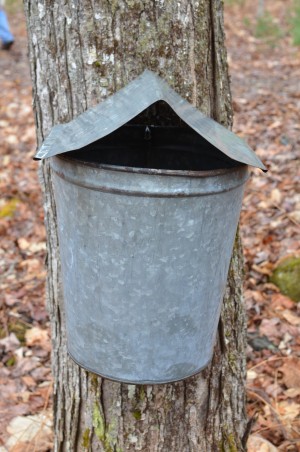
[25,0,246,452]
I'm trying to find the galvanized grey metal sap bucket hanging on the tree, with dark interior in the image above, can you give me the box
[51,126,248,384]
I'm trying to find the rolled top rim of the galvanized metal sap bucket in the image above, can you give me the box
[55,152,248,178]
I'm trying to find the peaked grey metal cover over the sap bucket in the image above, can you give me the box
[35,70,266,171]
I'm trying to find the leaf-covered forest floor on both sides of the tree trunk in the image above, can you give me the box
[0,0,300,452]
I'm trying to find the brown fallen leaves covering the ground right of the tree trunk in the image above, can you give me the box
[225,0,300,452]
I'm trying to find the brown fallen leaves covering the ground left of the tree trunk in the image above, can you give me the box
[0,7,52,452]
